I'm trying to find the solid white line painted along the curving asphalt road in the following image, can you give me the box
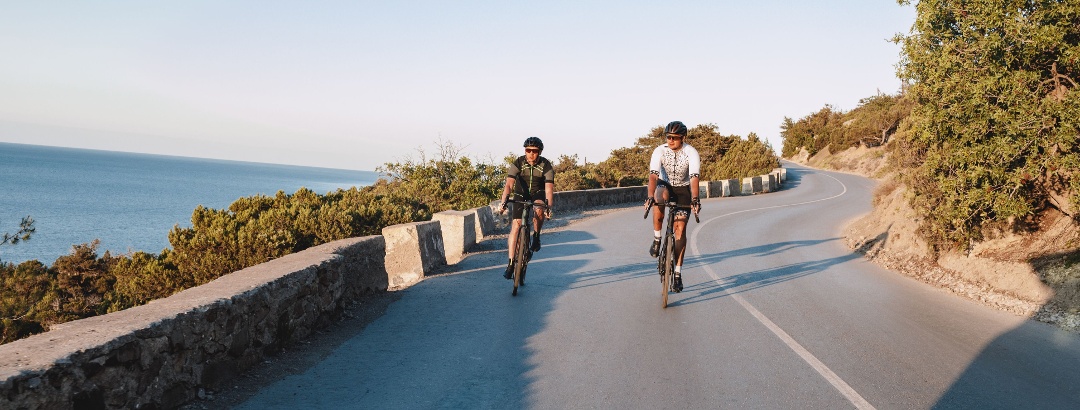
[690,170,874,410]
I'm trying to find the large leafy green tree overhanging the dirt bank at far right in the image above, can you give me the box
[894,0,1080,248]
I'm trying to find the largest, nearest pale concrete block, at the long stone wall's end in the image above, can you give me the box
[382,221,446,289]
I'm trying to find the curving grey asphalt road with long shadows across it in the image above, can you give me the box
[240,164,1080,409]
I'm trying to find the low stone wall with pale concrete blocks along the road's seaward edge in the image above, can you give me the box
[0,172,786,409]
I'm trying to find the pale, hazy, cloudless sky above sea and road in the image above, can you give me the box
[0,0,915,170]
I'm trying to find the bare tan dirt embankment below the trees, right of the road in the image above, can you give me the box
[787,147,1080,332]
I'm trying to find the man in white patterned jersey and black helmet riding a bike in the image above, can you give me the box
[645,121,701,292]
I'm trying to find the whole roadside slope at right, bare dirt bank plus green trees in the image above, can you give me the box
[783,1,1080,329]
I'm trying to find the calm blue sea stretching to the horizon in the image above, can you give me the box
[0,142,378,265]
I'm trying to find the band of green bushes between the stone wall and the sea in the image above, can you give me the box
[0,128,778,343]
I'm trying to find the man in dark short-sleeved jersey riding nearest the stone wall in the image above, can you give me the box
[500,137,555,279]
